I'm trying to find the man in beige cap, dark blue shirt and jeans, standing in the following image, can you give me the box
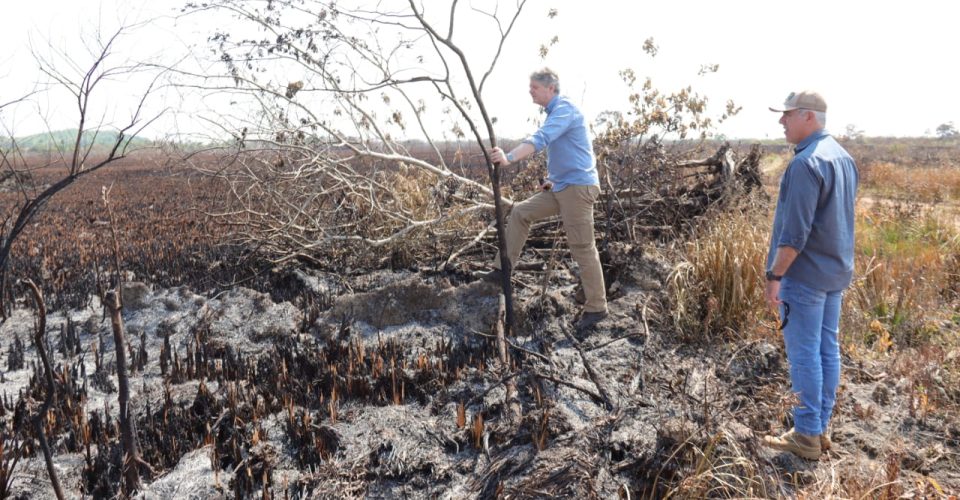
[764,91,859,460]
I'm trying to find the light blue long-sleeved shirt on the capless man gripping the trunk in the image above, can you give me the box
[523,95,600,192]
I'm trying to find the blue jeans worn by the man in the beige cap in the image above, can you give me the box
[780,278,843,436]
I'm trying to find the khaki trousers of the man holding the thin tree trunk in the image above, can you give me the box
[494,186,607,312]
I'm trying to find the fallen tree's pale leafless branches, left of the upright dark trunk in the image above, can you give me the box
[179,0,525,262]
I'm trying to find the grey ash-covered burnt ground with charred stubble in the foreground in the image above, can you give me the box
[0,246,960,498]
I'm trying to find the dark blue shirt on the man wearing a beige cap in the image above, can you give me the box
[767,130,860,292]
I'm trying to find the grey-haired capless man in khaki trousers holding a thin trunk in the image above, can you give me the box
[484,68,607,330]
